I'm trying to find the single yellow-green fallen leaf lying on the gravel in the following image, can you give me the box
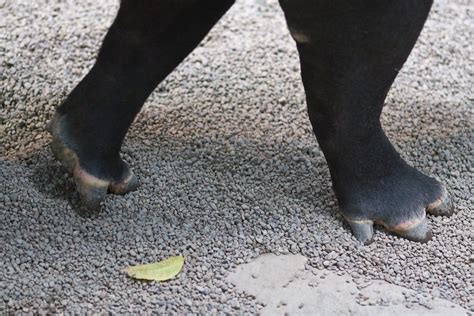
[125,256,184,281]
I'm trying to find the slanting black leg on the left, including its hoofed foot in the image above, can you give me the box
[50,0,234,208]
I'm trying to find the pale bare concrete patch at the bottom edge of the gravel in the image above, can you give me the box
[228,254,468,316]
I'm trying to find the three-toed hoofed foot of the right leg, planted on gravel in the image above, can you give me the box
[336,165,453,244]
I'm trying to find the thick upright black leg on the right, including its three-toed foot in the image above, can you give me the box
[280,0,451,242]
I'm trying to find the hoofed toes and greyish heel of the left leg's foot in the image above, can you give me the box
[48,113,139,209]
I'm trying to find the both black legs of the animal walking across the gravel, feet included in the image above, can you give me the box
[49,0,452,243]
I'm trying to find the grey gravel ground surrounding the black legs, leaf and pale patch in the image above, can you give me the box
[0,0,474,314]
